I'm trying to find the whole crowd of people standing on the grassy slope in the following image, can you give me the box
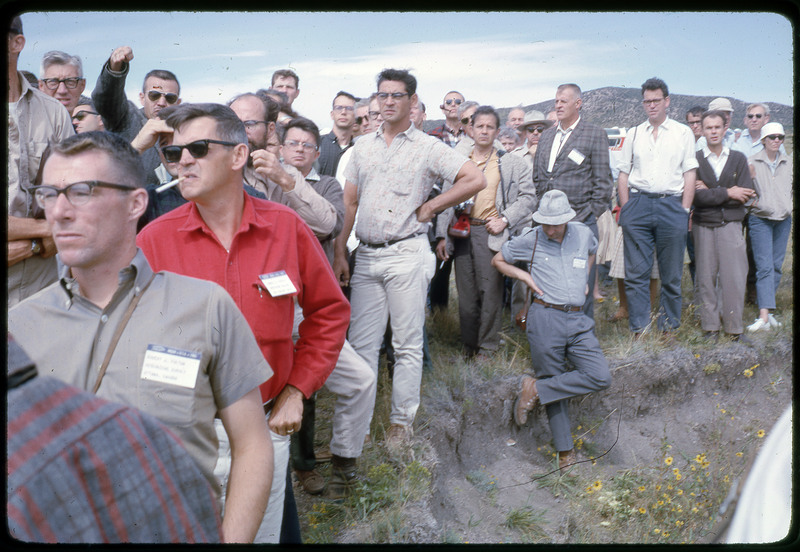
[8,17,793,543]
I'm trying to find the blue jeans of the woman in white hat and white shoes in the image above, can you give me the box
[748,215,792,310]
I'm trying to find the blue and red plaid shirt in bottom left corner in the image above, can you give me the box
[6,338,222,543]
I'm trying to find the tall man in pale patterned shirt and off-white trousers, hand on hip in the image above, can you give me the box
[333,69,486,452]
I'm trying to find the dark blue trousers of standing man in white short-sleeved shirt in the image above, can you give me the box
[619,192,689,332]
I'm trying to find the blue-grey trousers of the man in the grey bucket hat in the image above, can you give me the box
[527,303,611,452]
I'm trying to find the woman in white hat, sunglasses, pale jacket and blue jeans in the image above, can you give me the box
[747,123,793,332]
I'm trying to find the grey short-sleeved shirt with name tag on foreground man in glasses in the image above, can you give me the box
[8,251,272,493]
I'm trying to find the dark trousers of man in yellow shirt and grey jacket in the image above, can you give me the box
[453,226,503,354]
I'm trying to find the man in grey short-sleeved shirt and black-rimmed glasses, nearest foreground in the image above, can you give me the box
[8,132,272,542]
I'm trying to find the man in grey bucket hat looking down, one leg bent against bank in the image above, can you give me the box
[492,190,611,469]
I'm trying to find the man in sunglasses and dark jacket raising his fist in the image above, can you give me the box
[92,46,181,190]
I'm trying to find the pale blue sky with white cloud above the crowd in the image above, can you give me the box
[12,11,794,128]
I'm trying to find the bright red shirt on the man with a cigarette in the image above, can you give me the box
[136,195,350,402]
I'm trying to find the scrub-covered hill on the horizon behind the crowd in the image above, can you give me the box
[425,86,794,134]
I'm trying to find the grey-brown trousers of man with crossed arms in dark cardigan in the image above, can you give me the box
[692,222,747,334]
